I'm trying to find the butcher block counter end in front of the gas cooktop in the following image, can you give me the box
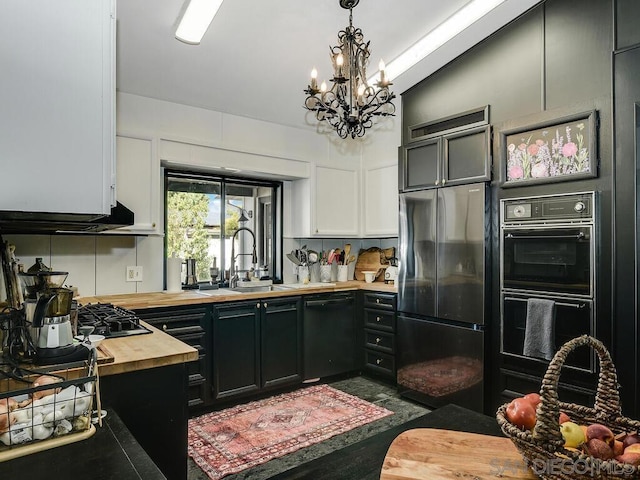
[99,322,198,376]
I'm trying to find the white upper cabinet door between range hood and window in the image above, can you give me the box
[111,135,162,234]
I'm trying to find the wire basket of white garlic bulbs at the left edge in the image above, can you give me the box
[0,355,99,461]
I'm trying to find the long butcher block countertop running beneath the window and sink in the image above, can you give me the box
[78,280,397,312]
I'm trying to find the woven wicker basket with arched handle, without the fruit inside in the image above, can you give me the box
[496,335,640,480]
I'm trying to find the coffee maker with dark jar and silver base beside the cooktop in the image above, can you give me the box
[18,270,89,365]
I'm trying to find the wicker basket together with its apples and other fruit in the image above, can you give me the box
[496,335,640,480]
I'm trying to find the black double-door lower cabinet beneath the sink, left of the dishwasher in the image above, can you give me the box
[212,297,302,401]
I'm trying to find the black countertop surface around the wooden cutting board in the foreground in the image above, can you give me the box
[272,405,503,480]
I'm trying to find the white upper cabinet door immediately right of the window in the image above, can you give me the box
[313,166,360,236]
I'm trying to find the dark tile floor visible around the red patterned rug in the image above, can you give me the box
[188,376,429,480]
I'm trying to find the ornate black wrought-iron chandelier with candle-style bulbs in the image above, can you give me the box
[304,0,396,138]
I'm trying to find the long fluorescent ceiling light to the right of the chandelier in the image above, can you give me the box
[369,0,505,84]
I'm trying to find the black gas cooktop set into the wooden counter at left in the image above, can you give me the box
[78,303,152,338]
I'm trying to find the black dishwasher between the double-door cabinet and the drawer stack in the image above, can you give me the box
[304,292,359,380]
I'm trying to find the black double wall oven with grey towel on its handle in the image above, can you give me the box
[500,192,597,373]
